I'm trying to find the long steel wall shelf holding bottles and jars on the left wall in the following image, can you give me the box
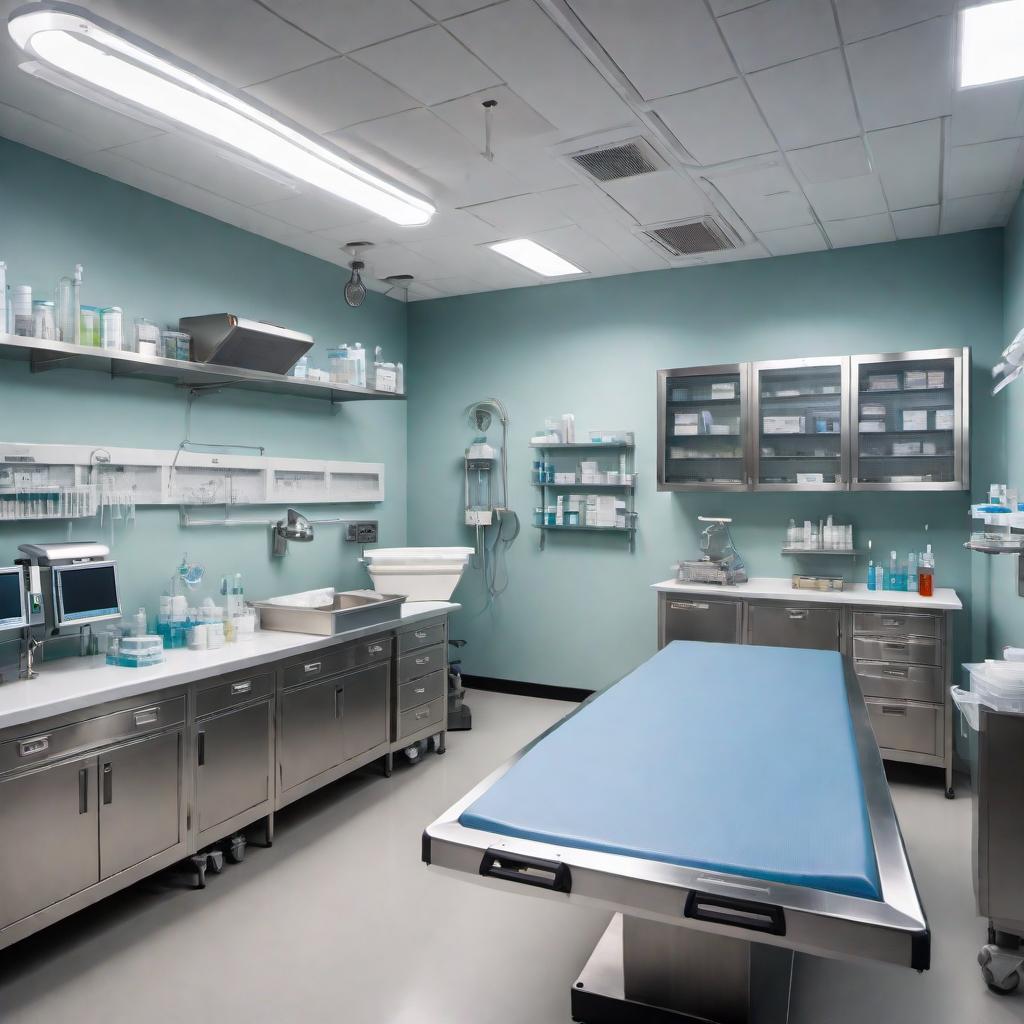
[0,334,406,406]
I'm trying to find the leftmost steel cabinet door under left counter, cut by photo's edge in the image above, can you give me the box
[0,757,99,928]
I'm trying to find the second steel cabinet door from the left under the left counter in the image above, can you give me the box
[99,732,184,879]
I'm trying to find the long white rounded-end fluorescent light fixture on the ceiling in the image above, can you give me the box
[7,3,435,225]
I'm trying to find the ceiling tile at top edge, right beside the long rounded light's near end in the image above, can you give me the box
[89,0,334,85]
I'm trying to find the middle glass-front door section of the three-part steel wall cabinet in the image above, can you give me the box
[751,356,850,490]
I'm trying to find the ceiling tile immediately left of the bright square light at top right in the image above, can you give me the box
[846,17,953,131]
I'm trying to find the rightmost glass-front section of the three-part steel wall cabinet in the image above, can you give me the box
[850,348,971,490]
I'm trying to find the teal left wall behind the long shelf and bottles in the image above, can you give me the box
[0,139,407,630]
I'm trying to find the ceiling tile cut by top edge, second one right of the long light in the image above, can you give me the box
[260,0,431,53]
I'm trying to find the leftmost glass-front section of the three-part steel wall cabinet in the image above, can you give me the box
[657,362,749,490]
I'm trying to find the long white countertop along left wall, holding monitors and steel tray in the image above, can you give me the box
[0,601,461,729]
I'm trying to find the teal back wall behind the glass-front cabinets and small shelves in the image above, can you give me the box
[409,230,999,687]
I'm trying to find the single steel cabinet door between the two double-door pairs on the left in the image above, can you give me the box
[196,700,273,833]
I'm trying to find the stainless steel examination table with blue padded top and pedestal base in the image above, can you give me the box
[423,642,931,1024]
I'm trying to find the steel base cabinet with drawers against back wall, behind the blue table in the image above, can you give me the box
[657,590,953,797]
